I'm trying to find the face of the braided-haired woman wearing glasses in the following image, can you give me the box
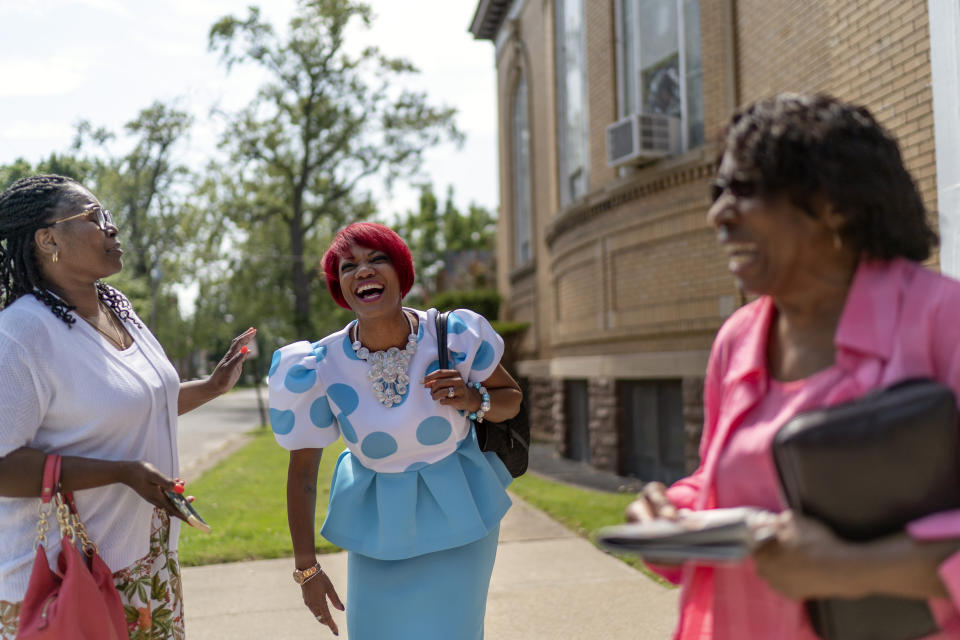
[35,185,123,282]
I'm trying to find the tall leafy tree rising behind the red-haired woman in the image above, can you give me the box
[209,0,461,337]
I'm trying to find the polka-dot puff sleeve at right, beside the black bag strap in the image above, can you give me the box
[447,309,503,382]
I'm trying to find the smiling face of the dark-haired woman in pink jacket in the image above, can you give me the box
[707,153,840,298]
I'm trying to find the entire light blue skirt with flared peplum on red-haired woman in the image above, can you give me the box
[321,429,512,640]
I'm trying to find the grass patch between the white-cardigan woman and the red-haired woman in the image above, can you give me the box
[179,429,343,566]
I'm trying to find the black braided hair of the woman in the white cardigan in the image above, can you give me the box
[0,175,143,329]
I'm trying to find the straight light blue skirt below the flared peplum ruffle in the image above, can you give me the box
[346,525,500,640]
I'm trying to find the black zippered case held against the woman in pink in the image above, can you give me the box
[773,379,960,640]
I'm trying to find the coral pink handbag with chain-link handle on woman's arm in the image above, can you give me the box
[17,454,128,640]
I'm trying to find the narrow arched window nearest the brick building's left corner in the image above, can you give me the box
[512,75,533,267]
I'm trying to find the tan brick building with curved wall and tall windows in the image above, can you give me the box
[470,0,940,481]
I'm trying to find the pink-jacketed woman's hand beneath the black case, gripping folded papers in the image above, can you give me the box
[753,511,864,600]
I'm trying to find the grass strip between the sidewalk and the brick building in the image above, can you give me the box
[510,473,674,587]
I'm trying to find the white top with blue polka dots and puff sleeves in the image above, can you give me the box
[269,309,503,473]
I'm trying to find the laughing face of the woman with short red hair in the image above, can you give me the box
[338,244,403,318]
